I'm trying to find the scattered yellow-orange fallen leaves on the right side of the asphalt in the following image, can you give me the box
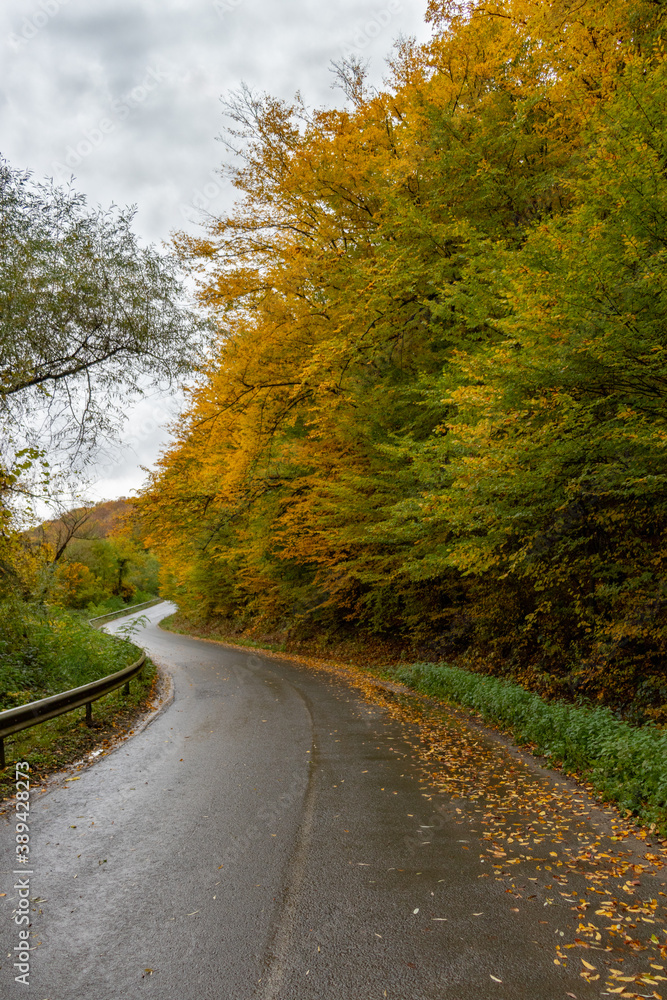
[264,632,667,1000]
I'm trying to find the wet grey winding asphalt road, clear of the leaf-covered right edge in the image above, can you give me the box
[0,604,599,1000]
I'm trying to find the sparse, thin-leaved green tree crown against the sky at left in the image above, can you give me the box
[0,160,202,461]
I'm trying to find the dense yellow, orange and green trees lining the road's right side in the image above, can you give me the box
[137,0,667,711]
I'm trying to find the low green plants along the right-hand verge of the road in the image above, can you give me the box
[160,615,667,837]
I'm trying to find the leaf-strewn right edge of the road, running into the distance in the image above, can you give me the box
[161,618,667,1000]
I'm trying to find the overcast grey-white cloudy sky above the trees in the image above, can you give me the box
[0,0,428,498]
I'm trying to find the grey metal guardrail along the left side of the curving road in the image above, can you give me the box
[0,601,159,768]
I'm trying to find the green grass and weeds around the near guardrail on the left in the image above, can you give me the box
[0,601,157,800]
